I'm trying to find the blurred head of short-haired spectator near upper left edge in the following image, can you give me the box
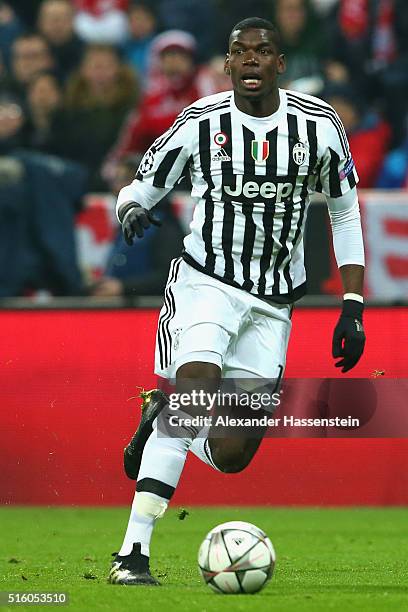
[9,32,54,99]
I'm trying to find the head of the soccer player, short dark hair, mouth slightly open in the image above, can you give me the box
[225,29,285,99]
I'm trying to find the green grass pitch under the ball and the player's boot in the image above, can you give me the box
[0,507,408,612]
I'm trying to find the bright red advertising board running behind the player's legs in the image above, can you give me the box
[0,308,408,505]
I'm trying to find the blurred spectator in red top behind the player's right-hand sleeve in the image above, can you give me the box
[324,84,391,188]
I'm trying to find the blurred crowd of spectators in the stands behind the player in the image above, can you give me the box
[0,0,408,296]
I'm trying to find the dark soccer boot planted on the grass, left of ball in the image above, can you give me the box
[108,542,160,586]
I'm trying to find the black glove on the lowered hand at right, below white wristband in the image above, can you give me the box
[333,300,365,372]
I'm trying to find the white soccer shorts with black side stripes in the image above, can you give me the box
[155,258,292,380]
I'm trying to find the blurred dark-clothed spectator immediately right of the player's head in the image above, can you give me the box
[274,0,326,94]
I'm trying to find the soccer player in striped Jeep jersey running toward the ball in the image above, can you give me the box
[109,18,365,585]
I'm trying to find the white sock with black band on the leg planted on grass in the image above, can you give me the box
[119,412,196,556]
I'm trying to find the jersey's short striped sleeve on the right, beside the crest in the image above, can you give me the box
[316,107,358,198]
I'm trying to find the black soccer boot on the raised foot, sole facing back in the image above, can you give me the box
[123,389,168,480]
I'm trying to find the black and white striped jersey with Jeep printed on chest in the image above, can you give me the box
[117,90,358,302]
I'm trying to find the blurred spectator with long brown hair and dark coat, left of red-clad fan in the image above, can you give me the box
[50,45,139,191]
